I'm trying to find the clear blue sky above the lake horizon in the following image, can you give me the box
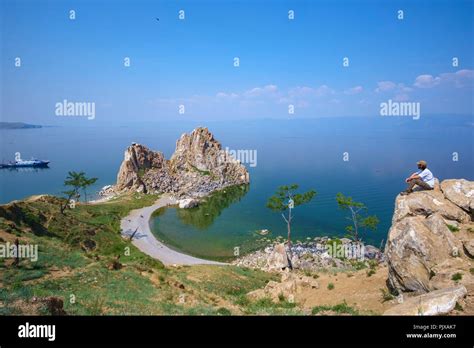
[1,0,474,124]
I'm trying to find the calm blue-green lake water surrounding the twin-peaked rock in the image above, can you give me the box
[0,116,474,259]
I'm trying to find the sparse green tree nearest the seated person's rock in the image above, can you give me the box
[336,192,379,242]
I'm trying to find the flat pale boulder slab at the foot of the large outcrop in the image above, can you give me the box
[384,285,467,315]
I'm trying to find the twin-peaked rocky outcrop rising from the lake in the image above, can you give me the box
[115,128,249,197]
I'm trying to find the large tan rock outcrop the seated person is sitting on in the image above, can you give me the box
[385,180,474,293]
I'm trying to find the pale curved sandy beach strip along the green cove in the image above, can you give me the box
[120,195,226,265]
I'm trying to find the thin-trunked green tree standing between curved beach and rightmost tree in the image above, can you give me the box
[267,184,316,250]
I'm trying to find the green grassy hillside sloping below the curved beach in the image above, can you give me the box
[0,194,300,315]
